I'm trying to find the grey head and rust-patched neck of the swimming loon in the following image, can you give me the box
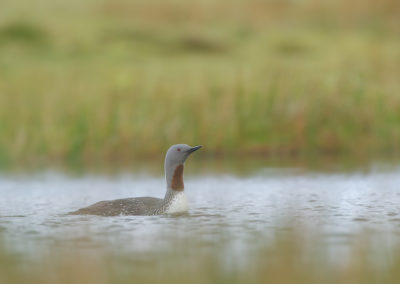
[165,144,202,191]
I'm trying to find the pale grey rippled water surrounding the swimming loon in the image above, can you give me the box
[0,164,400,268]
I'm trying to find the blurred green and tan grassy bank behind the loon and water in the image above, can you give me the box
[0,0,400,167]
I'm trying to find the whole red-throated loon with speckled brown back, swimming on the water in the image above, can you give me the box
[70,144,201,216]
